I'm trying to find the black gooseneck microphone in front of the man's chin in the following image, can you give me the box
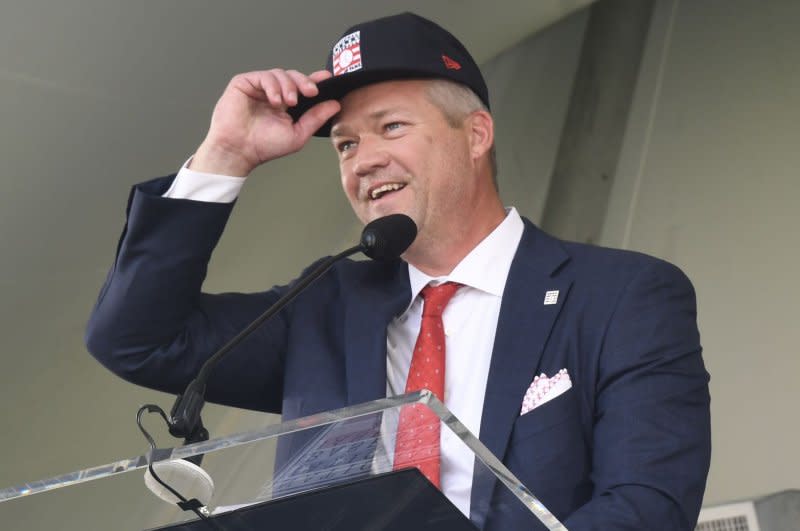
[168,214,417,442]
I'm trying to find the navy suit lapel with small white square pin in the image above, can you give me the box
[470,220,572,527]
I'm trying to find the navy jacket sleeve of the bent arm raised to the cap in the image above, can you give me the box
[86,177,287,412]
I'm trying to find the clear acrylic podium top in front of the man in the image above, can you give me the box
[0,390,565,531]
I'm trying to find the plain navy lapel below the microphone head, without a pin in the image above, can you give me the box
[342,260,411,405]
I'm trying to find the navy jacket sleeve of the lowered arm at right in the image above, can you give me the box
[564,261,711,530]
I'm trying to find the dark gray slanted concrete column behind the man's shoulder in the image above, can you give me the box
[542,0,653,243]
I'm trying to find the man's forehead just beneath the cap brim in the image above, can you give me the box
[331,80,436,136]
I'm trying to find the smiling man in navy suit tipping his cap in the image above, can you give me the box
[87,14,710,530]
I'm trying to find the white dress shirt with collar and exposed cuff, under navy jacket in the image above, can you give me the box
[164,164,523,516]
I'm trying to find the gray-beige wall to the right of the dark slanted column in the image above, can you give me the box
[603,0,800,503]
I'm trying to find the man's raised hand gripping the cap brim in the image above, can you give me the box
[191,68,340,177]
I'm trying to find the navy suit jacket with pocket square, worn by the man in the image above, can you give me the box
[87,178,710,531]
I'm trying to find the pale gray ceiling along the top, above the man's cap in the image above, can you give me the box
[0,0,589,105]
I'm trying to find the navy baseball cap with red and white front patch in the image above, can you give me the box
[287,13,489,137]
